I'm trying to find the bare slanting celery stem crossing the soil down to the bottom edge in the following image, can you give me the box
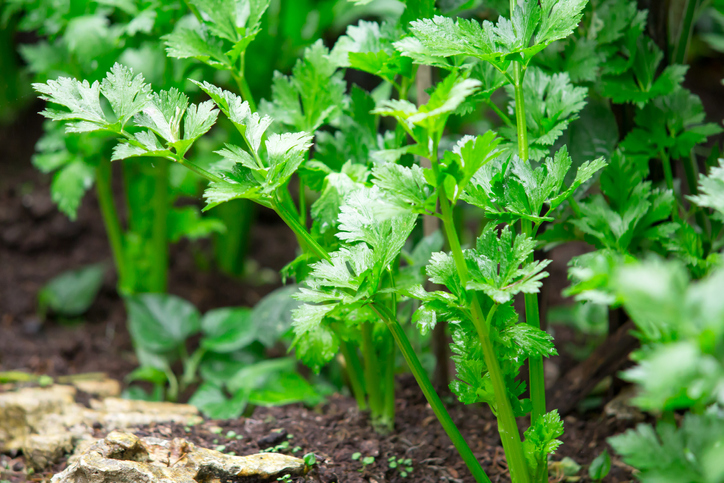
[370,304,490,483]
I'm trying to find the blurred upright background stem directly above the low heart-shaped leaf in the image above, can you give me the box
[149,158,169,293]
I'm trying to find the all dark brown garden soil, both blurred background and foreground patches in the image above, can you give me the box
[0,106,633,483]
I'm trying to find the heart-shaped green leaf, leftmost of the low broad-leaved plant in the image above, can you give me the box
[124,293,201,353]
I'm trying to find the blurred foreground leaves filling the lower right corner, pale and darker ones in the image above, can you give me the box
[576,255,724,482]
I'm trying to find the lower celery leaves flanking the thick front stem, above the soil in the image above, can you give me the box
[405,228,555,415]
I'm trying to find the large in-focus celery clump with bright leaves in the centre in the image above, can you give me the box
[32,0,603,482]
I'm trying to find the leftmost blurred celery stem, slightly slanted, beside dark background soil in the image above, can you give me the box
[96,157,129,293]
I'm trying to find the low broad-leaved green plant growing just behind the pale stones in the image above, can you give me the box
[126,286,319,419]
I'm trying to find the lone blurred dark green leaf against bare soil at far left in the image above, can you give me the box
[38,264,106,317]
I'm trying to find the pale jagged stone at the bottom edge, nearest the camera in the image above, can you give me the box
[52,431,305,483]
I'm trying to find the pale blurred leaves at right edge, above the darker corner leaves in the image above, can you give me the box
[614,261,724,410]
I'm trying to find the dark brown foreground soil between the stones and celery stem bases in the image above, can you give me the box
[0,376,631,483]
